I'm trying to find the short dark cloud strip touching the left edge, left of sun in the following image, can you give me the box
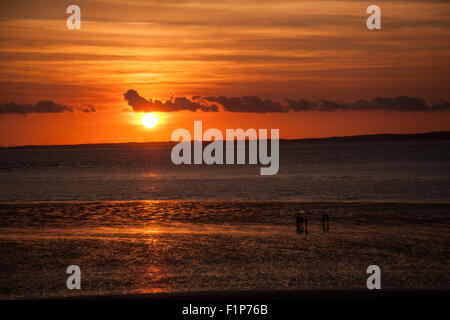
[0,100,96,114]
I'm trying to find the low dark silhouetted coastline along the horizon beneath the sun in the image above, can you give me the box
[0,131,450,149]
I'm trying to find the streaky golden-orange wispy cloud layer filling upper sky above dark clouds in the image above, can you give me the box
[0,0,450,104]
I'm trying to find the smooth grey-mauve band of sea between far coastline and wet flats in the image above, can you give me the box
[0,140,450,202]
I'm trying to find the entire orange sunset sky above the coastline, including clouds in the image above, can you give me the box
[0,0,450,146]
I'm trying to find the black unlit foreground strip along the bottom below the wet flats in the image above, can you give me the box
[0,290,450,320]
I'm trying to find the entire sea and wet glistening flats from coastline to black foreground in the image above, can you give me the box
[0,141,450,298]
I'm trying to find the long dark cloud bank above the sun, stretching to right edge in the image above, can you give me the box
[124,90,450,113]
